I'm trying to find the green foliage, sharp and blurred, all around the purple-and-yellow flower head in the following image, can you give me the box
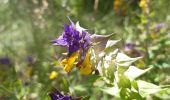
[0,0,170,100]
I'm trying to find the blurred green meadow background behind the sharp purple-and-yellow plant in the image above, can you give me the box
[0,0,170,100]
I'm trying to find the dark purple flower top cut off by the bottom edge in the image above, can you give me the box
[49,89,81,100]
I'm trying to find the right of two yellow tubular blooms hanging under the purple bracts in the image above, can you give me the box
[80,50,92,75]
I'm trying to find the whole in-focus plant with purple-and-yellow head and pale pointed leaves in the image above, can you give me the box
[50,19,169,100]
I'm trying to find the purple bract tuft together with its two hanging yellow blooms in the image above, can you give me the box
[52,20,92,74]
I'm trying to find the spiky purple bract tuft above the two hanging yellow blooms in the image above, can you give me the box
[52,20,90,58]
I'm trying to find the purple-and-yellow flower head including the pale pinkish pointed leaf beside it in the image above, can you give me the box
[52,20,113,75]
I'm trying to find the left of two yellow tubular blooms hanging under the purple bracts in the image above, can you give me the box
[61,51,78,73]
